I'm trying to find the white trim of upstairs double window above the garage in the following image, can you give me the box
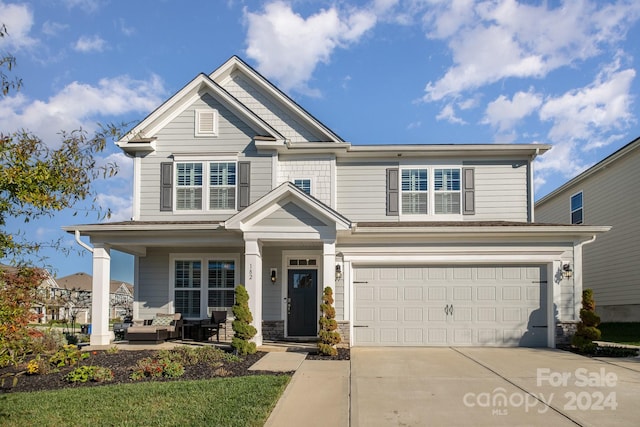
[398,160,463,221]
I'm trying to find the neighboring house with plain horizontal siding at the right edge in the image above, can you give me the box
[535,138,640,322]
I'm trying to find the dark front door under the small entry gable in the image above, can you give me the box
[287,270,318,337]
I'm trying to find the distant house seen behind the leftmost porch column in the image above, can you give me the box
[57,273,133,323]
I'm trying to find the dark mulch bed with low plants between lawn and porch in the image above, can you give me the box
[0,350,274,393]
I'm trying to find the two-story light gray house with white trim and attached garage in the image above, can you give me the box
[64,57,608,347]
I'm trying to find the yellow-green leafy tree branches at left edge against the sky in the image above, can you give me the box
[0,24,124,264]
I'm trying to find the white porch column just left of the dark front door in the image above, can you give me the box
[244,240,262,345]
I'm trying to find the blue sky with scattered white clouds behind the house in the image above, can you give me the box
[0,0,640,282]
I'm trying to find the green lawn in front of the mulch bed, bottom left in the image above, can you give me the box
[0,375,290,427]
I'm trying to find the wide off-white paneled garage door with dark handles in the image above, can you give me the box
[353,265,547,347]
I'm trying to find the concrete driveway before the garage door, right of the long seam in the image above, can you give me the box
[350,348,640,427]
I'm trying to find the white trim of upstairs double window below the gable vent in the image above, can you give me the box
[173,155,239,215]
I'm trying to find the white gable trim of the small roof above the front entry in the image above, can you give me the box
[224,182,351,230]
